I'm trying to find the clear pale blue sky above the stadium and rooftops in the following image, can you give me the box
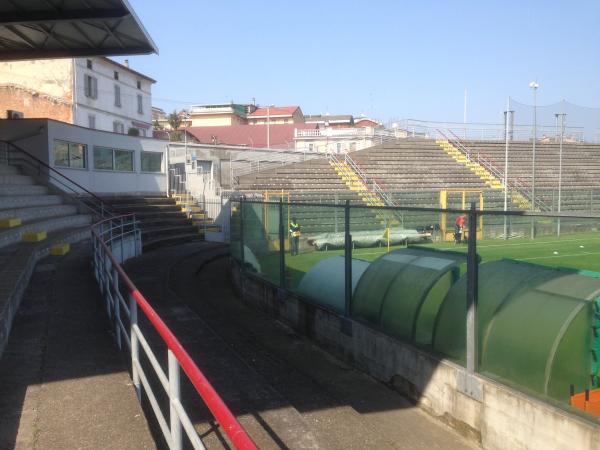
[117,0,600,123]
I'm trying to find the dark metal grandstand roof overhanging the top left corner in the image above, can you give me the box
[0,0,158,61]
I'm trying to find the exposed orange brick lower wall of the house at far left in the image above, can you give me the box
[0,84,73,123]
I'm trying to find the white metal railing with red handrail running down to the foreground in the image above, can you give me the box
[92,214,256,450]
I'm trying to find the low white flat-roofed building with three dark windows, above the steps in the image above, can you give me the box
[0,119,168,196]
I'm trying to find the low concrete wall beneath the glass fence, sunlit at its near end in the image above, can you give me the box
[232,261,600,450]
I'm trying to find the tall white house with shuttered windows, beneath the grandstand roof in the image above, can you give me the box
[0,57,155,136]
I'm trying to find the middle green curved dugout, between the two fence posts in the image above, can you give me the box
[352,247,466,346]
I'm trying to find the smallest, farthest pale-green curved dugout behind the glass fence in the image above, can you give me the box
[298,256,369,314]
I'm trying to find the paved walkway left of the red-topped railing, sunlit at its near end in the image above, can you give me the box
[0,244,155,450]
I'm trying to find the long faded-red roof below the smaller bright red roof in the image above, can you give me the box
[186,123,316,149]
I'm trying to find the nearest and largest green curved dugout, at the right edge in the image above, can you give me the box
[433,260,600,401]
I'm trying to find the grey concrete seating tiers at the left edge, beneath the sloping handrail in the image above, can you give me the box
[0,164,92,249]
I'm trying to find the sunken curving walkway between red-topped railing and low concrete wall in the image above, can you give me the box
[127,243,476,449]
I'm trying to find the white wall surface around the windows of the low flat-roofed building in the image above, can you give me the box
[0,119,167,195]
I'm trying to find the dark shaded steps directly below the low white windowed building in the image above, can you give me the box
[109,196,203,251]
